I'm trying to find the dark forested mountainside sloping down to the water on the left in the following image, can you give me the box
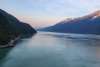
[0,9,36,45]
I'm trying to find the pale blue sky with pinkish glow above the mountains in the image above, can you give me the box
[0,0,100,28]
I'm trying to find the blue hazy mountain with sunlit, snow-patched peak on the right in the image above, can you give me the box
[39,11,100,34]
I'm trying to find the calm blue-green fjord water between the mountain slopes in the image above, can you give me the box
[0,32,100,67]
